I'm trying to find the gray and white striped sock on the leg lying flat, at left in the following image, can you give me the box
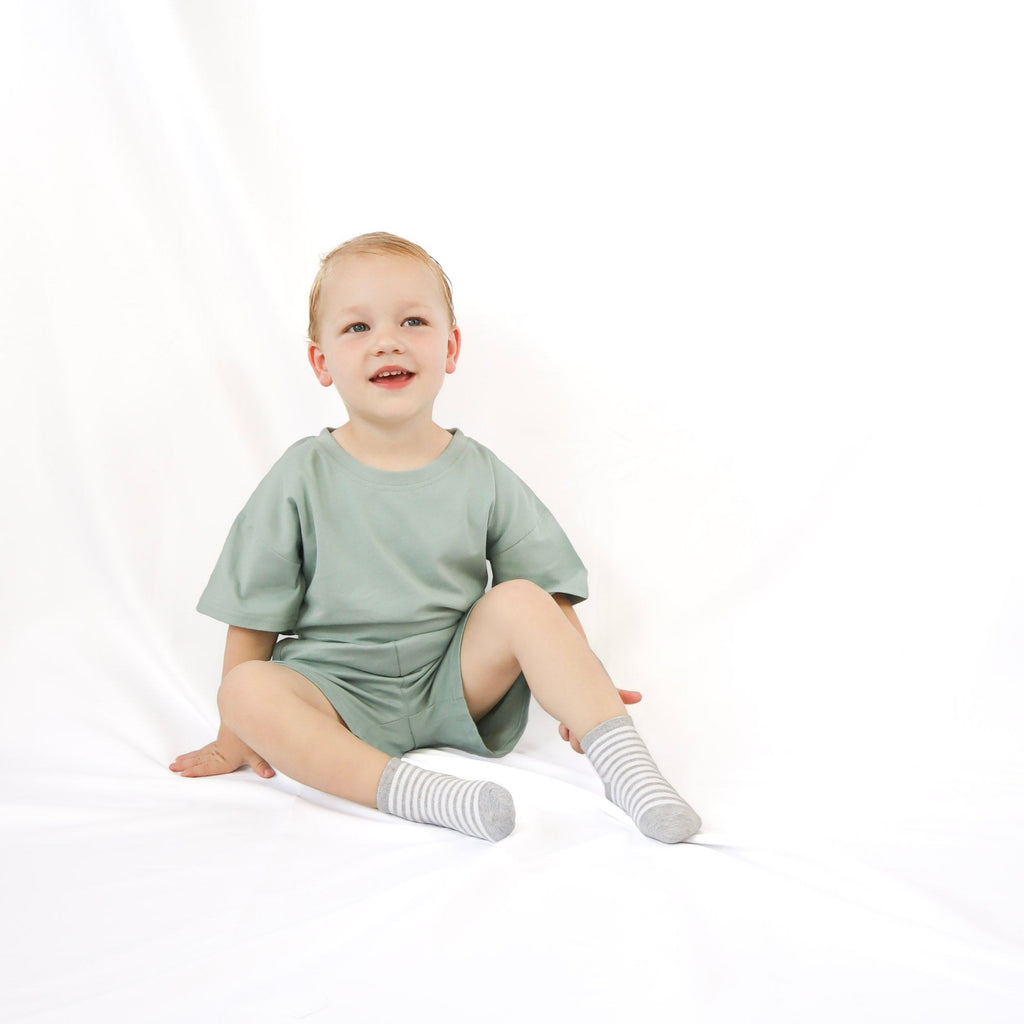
[377,758,515,843]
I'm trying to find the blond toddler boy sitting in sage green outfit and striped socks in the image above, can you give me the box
[170,232,700,843]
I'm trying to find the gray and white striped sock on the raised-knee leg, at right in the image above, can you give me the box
[580,715,700,843]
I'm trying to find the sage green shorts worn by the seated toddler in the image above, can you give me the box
[271,609,529,758]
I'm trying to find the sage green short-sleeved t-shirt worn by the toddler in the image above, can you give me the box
[198,428,587,658]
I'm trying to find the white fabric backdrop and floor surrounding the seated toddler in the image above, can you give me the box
[6,0,1024,1024]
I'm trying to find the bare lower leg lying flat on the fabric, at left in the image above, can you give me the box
[217,662,390,807]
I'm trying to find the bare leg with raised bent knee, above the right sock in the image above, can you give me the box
[461,580,626,736]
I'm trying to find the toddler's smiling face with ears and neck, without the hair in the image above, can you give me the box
[309,253,460,427]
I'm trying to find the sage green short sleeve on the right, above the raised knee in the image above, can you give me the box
[487,459,588,603]
